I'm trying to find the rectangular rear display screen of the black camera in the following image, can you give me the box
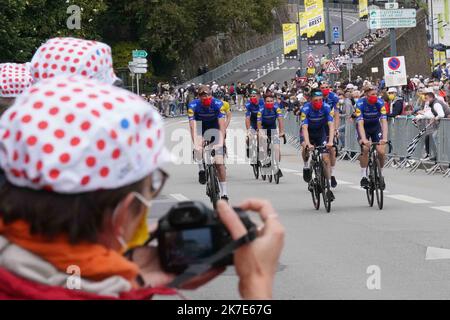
[165,228,214,266]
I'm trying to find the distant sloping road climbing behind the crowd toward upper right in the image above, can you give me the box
[219,12,368,84]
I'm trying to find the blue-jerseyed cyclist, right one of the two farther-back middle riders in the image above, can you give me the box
[257,94,284,178]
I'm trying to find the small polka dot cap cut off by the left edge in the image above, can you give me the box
[0,63,34,98]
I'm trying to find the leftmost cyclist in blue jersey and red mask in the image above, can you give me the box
[188,85,228,201]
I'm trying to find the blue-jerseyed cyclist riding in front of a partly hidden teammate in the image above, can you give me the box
[300,89,335,201]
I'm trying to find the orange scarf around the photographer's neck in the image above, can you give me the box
[0,219,139,285]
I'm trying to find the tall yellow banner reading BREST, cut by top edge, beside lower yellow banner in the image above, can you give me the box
[305,0,326,45]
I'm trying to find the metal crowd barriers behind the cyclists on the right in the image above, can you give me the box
[285,112,450,177]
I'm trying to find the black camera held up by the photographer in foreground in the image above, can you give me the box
[157,201,256,274]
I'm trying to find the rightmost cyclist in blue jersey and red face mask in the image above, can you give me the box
[355,86,388,190]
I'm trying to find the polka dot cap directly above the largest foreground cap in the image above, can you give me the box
[31,38,118,84]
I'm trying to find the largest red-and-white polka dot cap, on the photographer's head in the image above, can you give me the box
[0,76,170,194]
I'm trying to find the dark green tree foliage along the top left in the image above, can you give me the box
[0,0,286,75]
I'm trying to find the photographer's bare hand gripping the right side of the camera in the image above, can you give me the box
[217,199,284,299]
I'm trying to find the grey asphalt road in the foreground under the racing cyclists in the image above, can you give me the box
[150,112,450,299]
